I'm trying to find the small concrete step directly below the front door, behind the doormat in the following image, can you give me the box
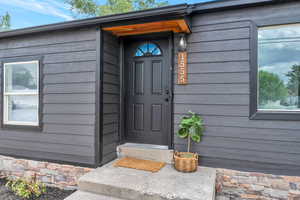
[117,143,174,164]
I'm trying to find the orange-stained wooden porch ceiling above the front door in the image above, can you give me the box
[103,19,191,36]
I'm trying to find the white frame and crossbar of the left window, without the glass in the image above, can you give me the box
[2,60,40,126]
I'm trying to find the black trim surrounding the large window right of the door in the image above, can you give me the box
[249,17,300,121]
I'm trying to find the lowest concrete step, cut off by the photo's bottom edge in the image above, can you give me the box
[64,191,124,200]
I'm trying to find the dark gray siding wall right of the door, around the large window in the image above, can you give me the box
[174,2,300,175]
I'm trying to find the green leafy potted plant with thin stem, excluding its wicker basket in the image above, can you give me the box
[177,111,204,152]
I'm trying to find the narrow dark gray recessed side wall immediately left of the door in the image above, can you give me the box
[102,31,120,164]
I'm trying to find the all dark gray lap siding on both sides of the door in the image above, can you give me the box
[0,2,300,175]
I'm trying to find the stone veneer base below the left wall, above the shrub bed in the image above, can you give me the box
[0,155,92,189]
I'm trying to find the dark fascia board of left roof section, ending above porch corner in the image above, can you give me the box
[0,4,188,39]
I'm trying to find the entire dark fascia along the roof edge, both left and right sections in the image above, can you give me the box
[0,0,298,39]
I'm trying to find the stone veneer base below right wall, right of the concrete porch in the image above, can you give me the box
[216,169,300,200]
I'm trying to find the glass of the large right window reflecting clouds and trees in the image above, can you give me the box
[258,25,300,111]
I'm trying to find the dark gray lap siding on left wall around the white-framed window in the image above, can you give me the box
[0,28,96,164]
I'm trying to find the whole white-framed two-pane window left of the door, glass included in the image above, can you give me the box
[3,60,39,126]
